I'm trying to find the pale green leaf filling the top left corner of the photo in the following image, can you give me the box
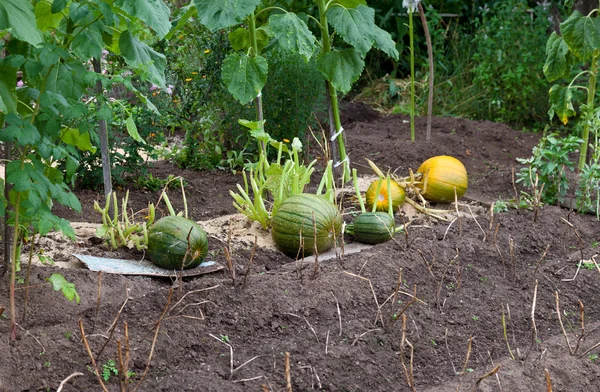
[0,0,43,45]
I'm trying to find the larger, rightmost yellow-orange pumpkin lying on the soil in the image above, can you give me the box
[417,155,469,203]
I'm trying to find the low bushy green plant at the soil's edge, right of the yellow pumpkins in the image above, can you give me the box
[517,134,581,204]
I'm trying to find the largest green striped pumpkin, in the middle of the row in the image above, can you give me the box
[271,193,342,257]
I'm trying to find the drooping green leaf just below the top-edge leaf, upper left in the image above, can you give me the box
[119,30,167,89]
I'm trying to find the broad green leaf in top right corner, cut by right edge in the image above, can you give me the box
[560,11,600,61]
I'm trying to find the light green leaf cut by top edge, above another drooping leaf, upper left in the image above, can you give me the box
[115,0,171,38]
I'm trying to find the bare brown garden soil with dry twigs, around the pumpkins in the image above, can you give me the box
[0,107,600,391]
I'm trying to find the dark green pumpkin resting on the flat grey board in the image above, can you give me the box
[146,216,208,270]
